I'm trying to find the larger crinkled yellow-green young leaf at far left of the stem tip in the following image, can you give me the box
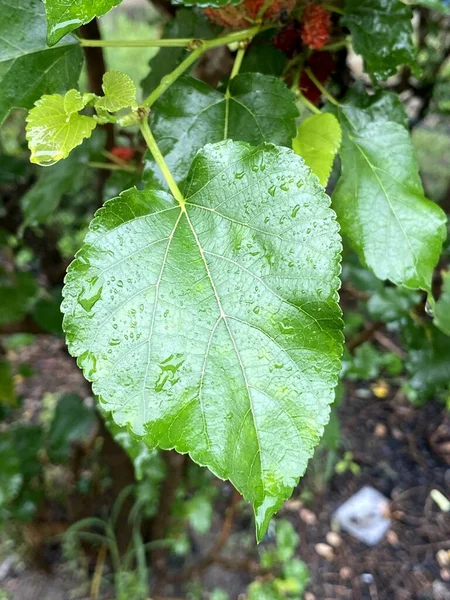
[27,94,97,166]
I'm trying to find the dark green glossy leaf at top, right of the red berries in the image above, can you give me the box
[342,0,416,79]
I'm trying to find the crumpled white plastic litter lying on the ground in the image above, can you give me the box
[333,486,391,546]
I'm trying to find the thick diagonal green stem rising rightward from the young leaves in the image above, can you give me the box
[142,24,273,108]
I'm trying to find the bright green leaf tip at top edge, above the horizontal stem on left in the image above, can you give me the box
[44,0,122,46]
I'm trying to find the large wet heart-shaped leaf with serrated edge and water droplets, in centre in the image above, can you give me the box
[62,141,342,539]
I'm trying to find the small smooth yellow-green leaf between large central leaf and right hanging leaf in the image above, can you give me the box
[292,113,342,186]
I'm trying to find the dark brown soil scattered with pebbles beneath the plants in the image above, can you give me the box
[0,336,450,600]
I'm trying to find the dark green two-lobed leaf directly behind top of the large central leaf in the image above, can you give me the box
[147,73,298,181]
